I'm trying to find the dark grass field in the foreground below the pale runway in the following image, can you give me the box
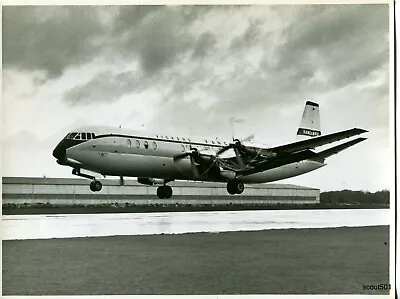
[3,226,389,295]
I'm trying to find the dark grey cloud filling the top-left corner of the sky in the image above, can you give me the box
[3,6,108,77]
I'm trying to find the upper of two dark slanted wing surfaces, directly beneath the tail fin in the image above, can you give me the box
[269,128,368,153]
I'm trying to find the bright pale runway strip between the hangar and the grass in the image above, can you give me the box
[2,209,391,240]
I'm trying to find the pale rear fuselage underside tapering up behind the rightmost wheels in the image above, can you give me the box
[240,160,325,183]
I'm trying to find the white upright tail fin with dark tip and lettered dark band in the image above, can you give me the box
[297,101,321,139]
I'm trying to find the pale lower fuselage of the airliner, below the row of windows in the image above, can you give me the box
[67,147,325,183]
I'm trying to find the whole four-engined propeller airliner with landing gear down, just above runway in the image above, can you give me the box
[53,101,368,198]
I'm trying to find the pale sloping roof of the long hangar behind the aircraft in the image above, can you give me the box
[2,177,319,190]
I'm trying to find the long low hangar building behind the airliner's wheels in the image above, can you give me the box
[2,177,320,205]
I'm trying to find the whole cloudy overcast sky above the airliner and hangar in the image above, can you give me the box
[2,5,392,191]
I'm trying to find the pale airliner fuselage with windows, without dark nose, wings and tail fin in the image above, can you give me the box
[57,135,325,183]
